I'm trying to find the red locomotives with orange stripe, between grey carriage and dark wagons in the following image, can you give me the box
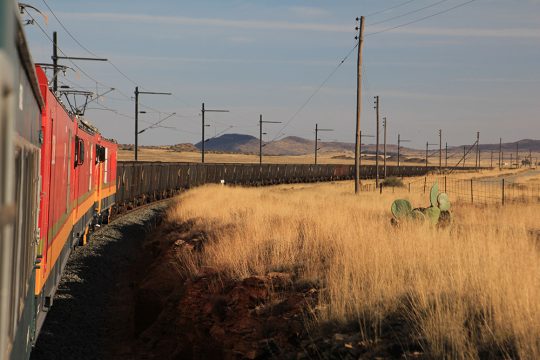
[35,66,117,331]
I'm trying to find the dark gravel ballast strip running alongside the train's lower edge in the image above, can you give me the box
[31,202,167,360]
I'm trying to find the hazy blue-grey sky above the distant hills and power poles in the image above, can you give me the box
[25,0,540,148]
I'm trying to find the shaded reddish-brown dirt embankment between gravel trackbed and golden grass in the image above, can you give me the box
[115,223,422,360]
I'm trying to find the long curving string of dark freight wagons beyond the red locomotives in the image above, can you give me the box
[113,161,473,213]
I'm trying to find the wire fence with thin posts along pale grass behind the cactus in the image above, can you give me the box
[361,176,540,205]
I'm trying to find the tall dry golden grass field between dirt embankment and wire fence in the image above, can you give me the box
[169,182,540,359]
